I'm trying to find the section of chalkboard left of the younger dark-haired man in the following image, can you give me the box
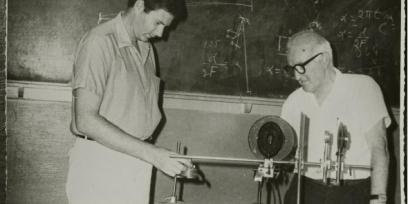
[7,0,127,83]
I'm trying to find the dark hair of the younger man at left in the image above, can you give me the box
[128,0,185,18]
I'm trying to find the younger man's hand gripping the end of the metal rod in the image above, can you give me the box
[152,147,193,177]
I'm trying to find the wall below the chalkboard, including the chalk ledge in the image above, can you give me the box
[7,85,400,204]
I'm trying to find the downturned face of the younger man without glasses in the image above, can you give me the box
[134,9,174,42]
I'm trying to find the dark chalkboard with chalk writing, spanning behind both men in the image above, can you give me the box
[8,0,400,105]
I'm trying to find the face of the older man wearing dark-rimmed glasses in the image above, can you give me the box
[287,48,326,93]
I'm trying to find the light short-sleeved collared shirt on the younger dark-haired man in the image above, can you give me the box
[72,13,161,139]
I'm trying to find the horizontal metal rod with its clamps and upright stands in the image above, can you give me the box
[168,116,371,204]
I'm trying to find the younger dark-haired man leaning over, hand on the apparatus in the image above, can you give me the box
[66,0,192,204]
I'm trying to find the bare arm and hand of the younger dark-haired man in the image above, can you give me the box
[74,88,192,176]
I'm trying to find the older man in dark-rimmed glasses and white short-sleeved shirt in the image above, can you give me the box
[281,31,391,204]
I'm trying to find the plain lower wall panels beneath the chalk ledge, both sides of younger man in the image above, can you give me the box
[7,100,278,204]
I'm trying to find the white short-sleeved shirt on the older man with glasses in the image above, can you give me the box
[281,69,391,179]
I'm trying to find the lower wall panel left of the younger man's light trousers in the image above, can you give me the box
[7,100,73,204]
